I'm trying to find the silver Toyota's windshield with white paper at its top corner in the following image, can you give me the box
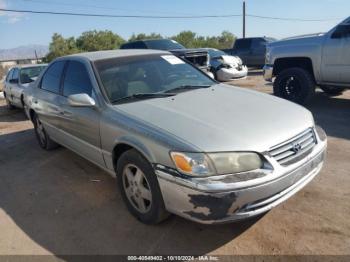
[94,54,216,103]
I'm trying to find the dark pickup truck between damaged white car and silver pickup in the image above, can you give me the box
[223,37,276,68]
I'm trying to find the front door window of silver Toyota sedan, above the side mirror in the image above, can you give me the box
[63,61,92,96]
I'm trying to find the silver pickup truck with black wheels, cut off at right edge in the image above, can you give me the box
[264,17,350,104]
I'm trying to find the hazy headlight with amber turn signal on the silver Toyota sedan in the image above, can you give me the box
[171,152,263,176]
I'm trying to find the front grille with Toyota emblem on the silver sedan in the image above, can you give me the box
[269,128,317,166]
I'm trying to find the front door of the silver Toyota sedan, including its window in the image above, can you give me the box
[60,60,105,166]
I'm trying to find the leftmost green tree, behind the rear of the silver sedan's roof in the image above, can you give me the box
[44,33,80,62]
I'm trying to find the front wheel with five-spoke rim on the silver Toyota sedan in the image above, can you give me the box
[116,149,169,224]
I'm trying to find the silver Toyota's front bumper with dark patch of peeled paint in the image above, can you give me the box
[156,136,327,224]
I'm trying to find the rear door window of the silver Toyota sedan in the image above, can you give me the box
[41,61,66,94]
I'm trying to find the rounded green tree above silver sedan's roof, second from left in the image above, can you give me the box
[76,30,125,52]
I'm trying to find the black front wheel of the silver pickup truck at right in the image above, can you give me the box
[273,67,315,104]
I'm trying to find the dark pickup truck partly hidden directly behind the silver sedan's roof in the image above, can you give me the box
[120,39,211,75]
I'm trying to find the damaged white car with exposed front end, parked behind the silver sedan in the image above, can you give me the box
[207,48,248,82]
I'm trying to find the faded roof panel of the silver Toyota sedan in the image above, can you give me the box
[65,49,170,61]
